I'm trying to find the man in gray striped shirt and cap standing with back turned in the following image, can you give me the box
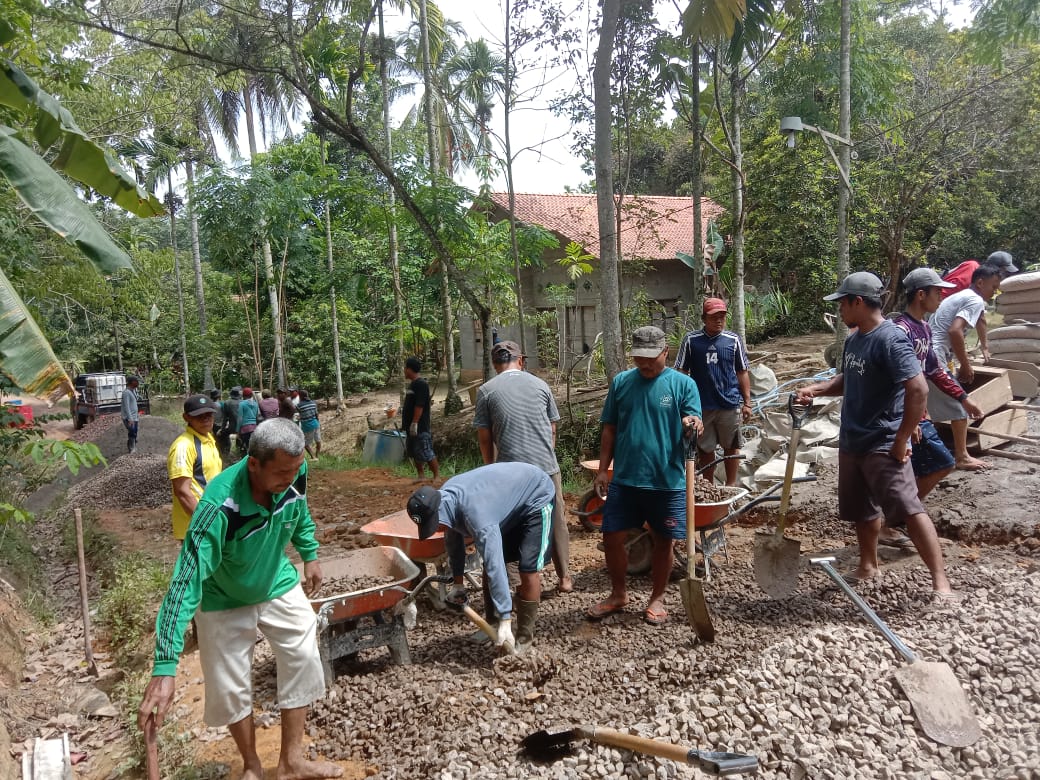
[473,341,574,593]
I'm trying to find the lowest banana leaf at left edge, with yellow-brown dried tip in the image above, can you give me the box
[0,270,73,404]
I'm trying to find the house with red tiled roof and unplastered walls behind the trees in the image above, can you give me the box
[460,192,723,375]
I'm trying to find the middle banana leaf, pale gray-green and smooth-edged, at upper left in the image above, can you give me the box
[0,125,132,272]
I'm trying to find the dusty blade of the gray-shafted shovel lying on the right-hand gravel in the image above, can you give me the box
[895,658,982,748]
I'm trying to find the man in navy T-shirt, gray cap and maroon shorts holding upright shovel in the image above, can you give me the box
[796,271,956,603]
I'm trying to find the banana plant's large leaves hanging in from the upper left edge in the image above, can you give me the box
[0,50,163,402]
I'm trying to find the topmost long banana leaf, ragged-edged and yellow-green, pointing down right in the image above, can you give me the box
[0,60,165,216]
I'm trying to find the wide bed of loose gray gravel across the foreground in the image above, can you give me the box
[238,560,1040,780]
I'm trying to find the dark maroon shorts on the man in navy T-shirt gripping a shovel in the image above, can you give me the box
[838,452,925,526]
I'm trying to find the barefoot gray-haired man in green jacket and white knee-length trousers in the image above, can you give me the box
[137,418,342,780]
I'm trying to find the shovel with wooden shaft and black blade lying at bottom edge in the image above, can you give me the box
[520,726,758,777]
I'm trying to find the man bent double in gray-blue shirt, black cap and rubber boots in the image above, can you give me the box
[408,463,555,652]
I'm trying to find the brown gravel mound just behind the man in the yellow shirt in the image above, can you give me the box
[67,452,171,510]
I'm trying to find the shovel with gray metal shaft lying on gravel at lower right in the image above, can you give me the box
[811,557,982,748]
